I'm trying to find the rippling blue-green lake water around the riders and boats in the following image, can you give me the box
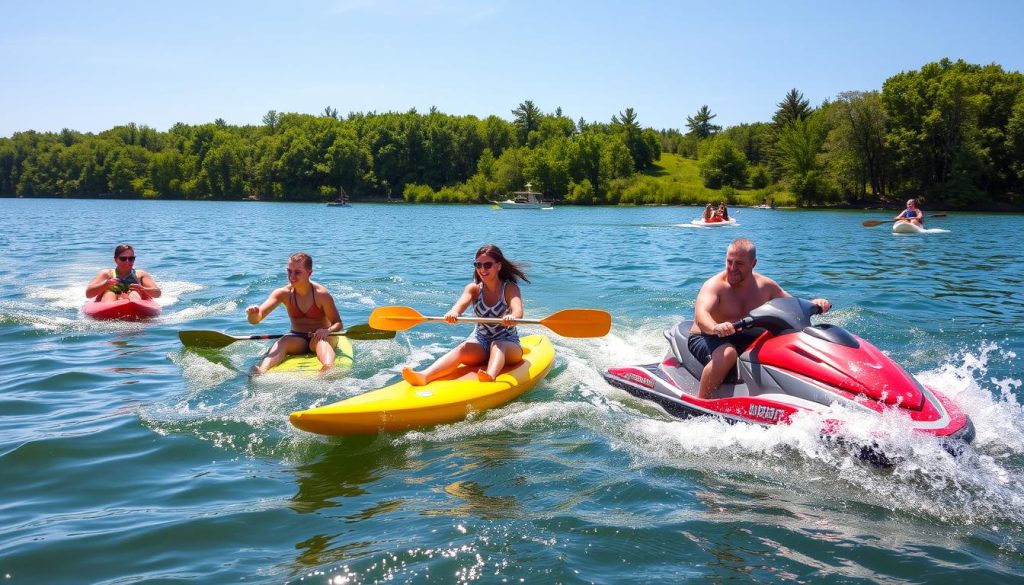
[0,199,1024,584]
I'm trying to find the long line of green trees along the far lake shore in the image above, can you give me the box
[0,59,1024,207]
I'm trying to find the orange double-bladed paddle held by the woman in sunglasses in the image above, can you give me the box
[370,306,611,337]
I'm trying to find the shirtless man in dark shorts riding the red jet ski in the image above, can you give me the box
[688,238,831,400]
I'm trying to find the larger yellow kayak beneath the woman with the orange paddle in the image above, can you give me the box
[291,335,555,434]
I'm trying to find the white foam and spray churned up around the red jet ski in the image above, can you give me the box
[584,314,1024,532]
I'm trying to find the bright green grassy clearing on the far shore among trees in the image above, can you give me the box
[617,153,797,207]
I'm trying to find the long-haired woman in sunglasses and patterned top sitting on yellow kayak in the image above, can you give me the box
[401,246,529,386]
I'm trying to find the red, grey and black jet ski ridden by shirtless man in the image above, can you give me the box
[604,297,975,464]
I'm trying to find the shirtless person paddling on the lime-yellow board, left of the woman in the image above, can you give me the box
[246,252,342,374]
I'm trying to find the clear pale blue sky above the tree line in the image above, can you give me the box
[0,0,1024,136]
